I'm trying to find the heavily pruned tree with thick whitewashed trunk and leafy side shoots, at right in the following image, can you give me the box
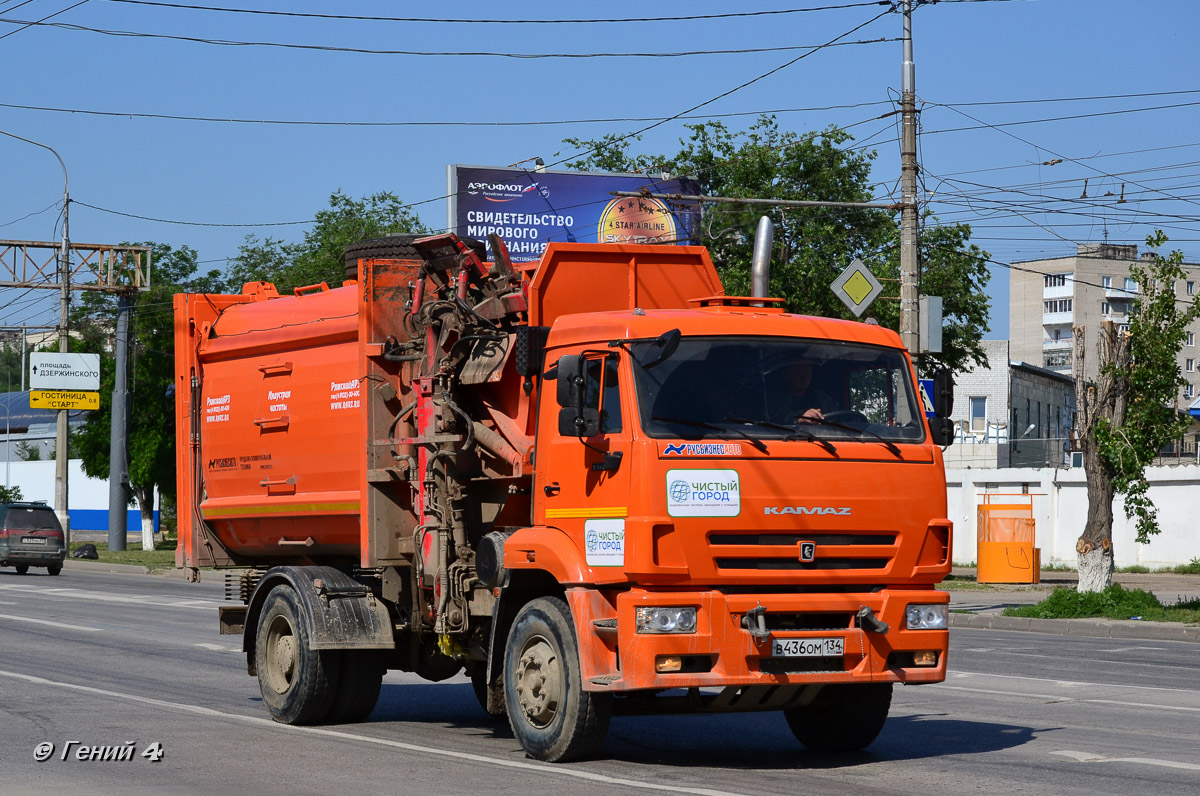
[1075,231,1200,592]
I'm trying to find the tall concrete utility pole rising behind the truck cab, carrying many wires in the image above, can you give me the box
[900,0,919,354]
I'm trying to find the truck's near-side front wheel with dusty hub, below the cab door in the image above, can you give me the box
[504,597,612,762]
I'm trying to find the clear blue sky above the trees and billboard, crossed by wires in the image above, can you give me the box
[0,0,1200,337]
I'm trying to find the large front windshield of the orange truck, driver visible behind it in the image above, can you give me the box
[632,337,925,443]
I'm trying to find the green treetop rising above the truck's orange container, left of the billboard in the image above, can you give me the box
[229,191,427,294]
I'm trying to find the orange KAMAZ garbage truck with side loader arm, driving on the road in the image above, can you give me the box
[174,234,953,761]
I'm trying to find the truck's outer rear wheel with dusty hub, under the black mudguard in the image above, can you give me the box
[254,585,340,724]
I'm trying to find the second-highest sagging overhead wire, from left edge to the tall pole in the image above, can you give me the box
[0,15,895,60]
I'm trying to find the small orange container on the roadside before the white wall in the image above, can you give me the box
[976,492,1042,583]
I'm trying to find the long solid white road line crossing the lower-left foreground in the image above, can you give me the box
[0,670,738,796]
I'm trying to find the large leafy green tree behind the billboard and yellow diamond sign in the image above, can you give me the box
[565,116,989,370]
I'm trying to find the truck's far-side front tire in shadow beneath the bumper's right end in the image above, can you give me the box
[784,683,892,753]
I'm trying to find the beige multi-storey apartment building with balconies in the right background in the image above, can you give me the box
[1008,244,1200,409]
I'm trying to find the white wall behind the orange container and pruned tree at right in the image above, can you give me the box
[946,465,1200,569]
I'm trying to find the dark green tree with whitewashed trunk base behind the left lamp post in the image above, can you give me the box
[71,243,224,550]
